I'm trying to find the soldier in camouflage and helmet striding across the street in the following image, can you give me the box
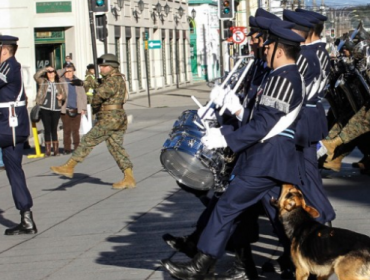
[51,54,136,189]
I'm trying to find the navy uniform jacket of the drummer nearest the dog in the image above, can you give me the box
[224,64,302,185]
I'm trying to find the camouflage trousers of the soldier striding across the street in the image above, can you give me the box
[72,115,133,173]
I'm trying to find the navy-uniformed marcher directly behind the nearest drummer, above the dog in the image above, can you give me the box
[283,10,335,226]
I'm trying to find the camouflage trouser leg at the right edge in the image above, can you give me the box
[329,106,370,143]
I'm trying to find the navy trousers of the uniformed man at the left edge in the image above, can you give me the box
[0,134,33,211]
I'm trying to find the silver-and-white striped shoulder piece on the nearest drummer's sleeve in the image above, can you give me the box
[259,76,294,113]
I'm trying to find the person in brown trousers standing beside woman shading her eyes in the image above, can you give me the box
[60,65,87,155]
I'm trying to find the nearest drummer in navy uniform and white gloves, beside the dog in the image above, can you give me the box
[162,22,304,279]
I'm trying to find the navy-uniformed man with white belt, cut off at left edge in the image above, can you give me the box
[0,35,37,235]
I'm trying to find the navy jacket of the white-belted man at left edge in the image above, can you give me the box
[0,57,30,136]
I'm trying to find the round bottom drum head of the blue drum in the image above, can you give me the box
[160,149,214,190]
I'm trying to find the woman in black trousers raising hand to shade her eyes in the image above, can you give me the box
[33,66,66,157]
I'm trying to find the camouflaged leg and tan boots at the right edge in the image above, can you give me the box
[321,105,370,172]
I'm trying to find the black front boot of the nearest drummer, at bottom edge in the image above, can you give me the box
[161,252,216,280]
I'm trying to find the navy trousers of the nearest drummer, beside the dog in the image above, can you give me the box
[198,176,289,258]
